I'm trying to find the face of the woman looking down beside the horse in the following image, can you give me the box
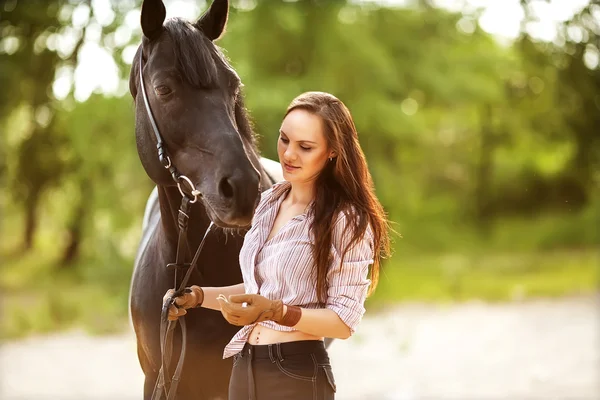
[277,109,333,183]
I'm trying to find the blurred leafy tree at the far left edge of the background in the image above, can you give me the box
[0,1,73,250]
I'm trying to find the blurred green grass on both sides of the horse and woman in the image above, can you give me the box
[0,244,600,339]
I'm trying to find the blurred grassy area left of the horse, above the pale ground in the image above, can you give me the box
[0,227,133,339]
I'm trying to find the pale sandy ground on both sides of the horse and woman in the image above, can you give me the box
[0,296,600,400]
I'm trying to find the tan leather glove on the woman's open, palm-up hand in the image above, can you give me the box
[217,294,283,326]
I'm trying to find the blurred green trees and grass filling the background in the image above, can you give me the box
[0,0,600,336]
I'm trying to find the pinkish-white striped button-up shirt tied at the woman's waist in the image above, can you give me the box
[223,181,374,358]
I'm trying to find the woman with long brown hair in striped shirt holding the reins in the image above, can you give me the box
[165,92,389,400]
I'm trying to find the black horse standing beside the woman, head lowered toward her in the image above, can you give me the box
[129,0,281,400]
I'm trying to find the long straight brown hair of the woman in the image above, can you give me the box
[285,92,390,303]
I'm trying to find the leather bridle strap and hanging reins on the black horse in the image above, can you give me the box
[139,47,214,400]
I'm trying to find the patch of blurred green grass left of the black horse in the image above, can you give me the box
[0,255,129,339]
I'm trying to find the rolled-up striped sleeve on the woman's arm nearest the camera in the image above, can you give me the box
[326,213,374,334]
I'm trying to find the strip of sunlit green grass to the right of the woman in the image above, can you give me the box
[369,249,600,308]
